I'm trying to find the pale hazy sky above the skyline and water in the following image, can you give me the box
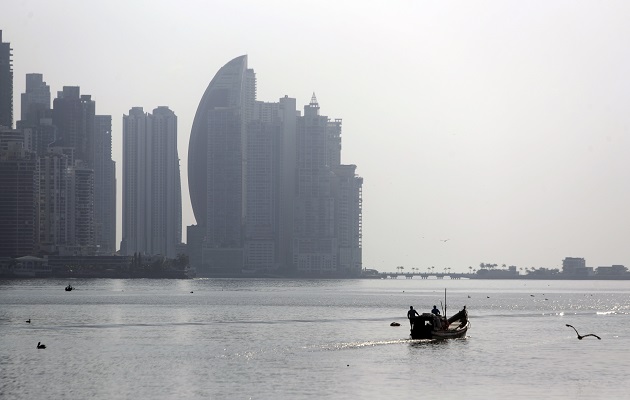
[0,0,630,271]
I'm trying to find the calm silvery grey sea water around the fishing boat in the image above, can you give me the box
[0,279,630,400]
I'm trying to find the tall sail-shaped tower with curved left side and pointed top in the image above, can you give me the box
[188,56,256,274]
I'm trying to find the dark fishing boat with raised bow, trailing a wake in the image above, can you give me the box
[411,306,470,339]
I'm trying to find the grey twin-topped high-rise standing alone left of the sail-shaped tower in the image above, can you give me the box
[121,107,182,258]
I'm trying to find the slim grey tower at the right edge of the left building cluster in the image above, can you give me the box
[92,115,116,255]
